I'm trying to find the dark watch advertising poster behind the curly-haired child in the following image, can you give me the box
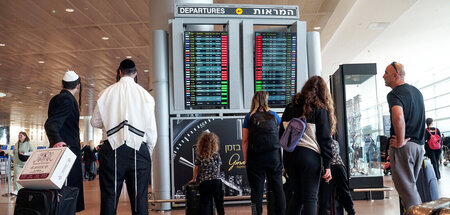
[171,117,250,199]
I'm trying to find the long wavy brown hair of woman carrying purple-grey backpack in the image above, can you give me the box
[294,76,336,134]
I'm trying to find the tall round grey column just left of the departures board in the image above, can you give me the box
[149,0,213,210]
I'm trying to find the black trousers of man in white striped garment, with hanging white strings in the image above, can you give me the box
[98,141,151,215]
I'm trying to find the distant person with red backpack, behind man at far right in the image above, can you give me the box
[425,118,442,180]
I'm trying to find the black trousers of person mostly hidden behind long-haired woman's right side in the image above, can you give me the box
[319,165,355,215]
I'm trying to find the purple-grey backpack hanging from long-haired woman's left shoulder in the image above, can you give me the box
[280,117,306,152]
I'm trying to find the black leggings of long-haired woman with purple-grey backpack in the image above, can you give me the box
[284,146,321,215]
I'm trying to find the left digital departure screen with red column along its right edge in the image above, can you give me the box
[185,32,229,109]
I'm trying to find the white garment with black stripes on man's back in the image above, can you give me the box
[91,76,157,155]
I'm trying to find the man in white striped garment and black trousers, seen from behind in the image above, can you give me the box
[91,59,157,215]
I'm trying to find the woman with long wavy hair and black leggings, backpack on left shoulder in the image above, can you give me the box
[280,76,336,215]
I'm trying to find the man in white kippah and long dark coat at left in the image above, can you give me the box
[45,71,84,212]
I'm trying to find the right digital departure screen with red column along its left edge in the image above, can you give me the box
[255,32,297,107]
